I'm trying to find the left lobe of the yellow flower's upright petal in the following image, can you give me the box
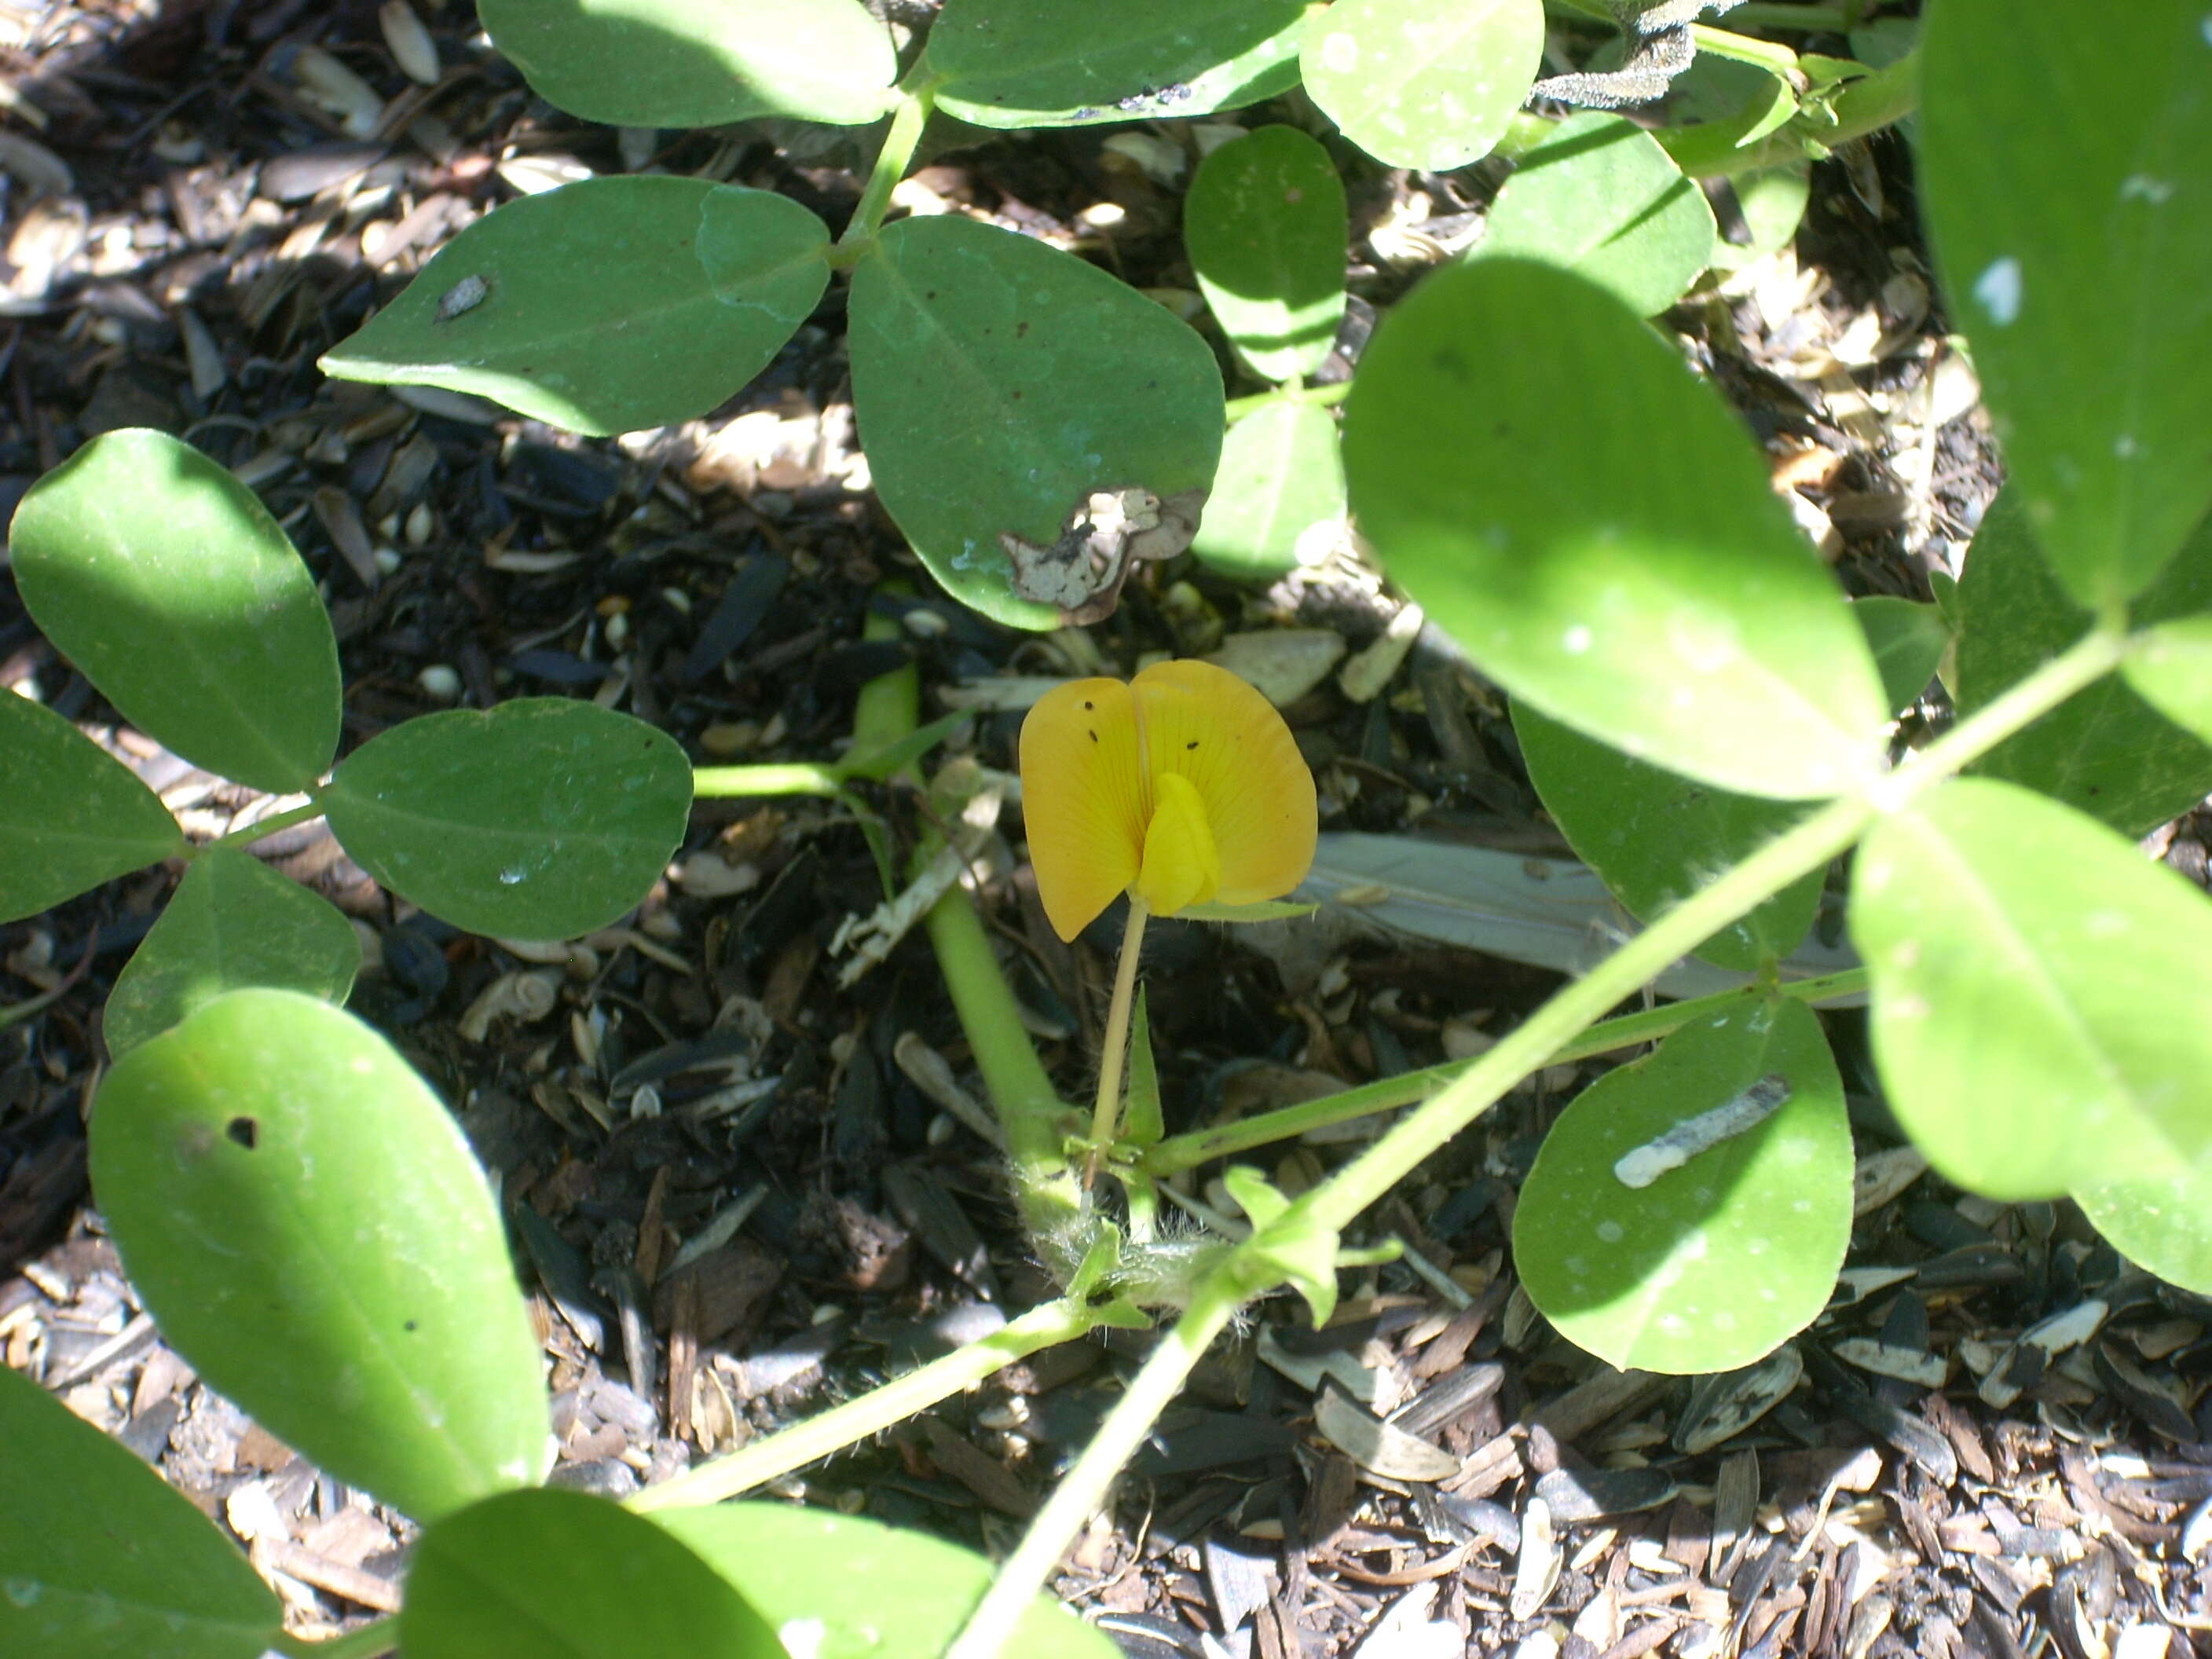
[1022,679,1150,940]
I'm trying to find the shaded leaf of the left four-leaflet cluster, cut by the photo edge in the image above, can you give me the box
[0,690,184,922]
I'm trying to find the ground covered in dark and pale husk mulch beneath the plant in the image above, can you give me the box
[0,0,2212,1659]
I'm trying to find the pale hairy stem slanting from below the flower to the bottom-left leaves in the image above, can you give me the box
[632,1298,1097,1522]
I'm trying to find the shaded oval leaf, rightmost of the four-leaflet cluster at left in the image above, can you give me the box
[323,697,690,938]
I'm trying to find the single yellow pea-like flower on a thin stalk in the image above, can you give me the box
[1022,661,1318,940]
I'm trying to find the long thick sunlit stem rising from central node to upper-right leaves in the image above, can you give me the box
[1301,628,2126,1230]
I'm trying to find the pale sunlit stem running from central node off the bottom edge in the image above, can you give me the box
[944,1263,1250,1659]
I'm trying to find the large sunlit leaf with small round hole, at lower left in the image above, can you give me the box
[90,991,547,1520]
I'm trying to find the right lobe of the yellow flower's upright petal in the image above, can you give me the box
[1130,661,1318,905]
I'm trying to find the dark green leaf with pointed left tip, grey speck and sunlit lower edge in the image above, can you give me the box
[320,174,830,436]
